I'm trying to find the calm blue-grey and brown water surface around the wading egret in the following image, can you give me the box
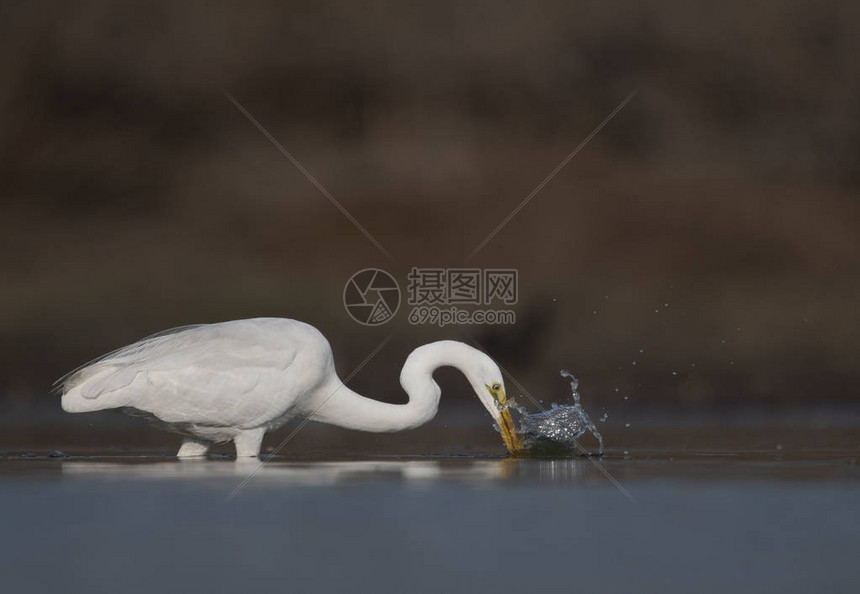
[0,410,860,594]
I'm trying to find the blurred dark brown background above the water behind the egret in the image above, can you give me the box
[0,1,860,416]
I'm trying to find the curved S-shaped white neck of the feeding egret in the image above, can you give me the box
[310,340,493,432]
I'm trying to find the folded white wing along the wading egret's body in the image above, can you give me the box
[57,324,314,426]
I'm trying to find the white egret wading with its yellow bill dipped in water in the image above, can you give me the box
[57,318,519,458]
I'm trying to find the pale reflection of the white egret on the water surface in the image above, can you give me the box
[62,458,589,486]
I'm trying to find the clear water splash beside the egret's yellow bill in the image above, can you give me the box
[512,370,603,456]
